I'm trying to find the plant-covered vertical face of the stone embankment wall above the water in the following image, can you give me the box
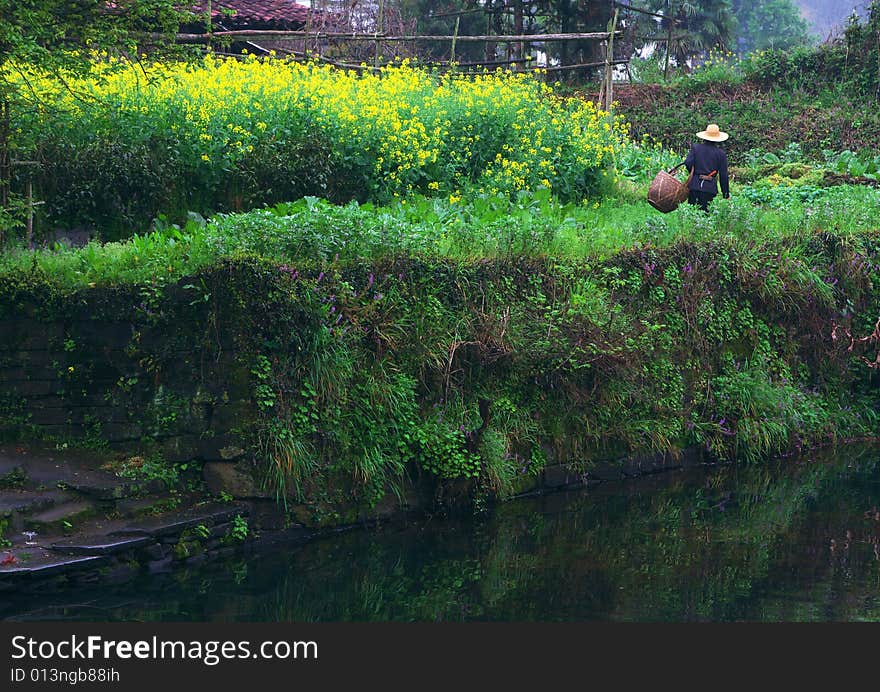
[0,246,877,510]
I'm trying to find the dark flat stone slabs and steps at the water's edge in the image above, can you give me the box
[0,443,250,594]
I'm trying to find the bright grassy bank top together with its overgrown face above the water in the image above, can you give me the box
[0,186,880,506]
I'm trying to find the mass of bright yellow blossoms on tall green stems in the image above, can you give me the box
[13,55,629,203]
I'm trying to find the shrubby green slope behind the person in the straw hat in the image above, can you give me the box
[618,8,880,164]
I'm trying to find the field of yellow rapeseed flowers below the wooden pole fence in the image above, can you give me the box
[8,57,627,207]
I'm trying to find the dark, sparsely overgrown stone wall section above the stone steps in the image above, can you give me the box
[0,304,252,461]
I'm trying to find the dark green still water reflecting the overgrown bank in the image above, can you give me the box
[0,447,880,621]
